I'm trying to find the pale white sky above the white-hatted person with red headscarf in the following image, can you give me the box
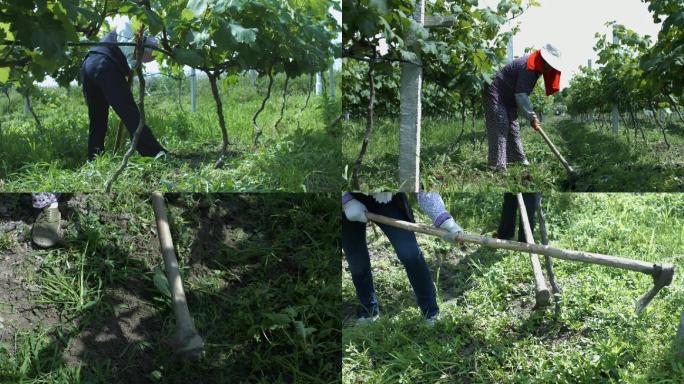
[480,0,660,87]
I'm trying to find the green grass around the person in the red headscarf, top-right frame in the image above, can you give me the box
[342,117,684,192]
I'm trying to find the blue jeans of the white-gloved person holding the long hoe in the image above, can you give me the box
[342,194,439,318]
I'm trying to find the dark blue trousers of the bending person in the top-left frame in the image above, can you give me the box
[81,53,164,160]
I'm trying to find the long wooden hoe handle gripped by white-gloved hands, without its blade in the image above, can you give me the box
[366,212,673,275]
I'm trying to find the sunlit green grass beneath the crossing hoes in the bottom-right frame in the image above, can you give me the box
[342,193,684,383]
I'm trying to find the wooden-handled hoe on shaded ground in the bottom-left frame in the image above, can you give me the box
[152,192,204,360]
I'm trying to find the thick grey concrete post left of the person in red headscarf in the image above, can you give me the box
[399,0,425,192]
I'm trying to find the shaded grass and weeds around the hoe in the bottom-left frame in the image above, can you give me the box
[0,194,341,384]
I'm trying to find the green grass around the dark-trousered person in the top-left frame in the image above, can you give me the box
[0,73,344,192]
